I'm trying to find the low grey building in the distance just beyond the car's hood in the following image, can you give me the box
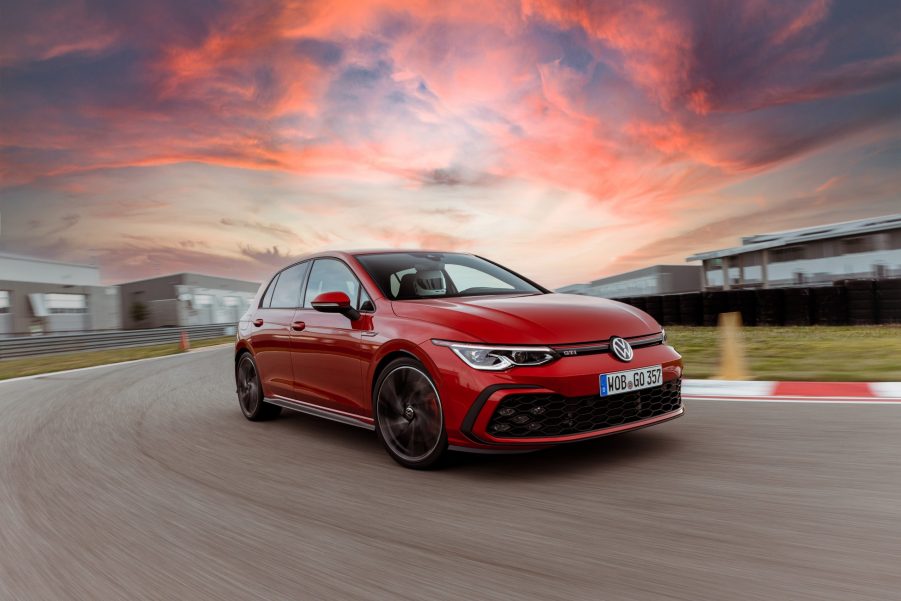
[557,265,701,298]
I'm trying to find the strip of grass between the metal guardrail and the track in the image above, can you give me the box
[0,336,235,380]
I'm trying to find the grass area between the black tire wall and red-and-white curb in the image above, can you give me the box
[666,326,901,382]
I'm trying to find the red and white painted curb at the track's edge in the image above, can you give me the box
[682,380,901,404]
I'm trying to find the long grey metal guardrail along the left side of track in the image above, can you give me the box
[0,323,236,359]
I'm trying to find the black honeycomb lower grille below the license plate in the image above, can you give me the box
[488,380,682,438]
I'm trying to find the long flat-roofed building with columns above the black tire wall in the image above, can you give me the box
[686,214,901,290]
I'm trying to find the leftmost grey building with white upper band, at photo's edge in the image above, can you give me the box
[0,253,122,336]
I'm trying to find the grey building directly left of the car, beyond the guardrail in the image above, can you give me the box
[120,273,260,329]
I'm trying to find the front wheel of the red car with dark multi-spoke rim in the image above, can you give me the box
[372,358,448,470]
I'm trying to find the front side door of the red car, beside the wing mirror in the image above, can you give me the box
[292,258,372,415]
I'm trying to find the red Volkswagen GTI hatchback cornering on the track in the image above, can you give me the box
[235,250,683,469]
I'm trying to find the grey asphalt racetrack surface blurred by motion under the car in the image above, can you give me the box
[0,348,901,601]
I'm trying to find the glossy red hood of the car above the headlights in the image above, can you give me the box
[393,294,660,344]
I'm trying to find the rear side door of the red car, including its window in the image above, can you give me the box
[251,261,310,399]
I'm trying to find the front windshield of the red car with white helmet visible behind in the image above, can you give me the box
[357,252,544,300]
